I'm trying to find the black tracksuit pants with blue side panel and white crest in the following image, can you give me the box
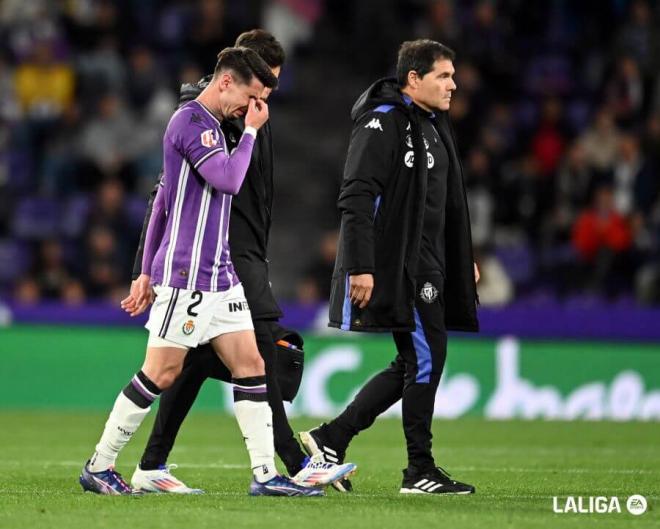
[325,275,447,473]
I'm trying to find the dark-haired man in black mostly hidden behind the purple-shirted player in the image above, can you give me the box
[122,30,354,494]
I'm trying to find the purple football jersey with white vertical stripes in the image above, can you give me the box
[143,100,254,292]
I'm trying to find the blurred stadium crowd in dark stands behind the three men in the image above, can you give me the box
[0,0,660,304]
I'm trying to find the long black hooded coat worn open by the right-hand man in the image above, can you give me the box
[329,79,479,332]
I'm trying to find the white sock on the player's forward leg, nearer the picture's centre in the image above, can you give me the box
[234,400,277,483]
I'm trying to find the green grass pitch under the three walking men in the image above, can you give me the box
[0,411,660,529]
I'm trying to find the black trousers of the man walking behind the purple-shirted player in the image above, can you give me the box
[140,320,305,475]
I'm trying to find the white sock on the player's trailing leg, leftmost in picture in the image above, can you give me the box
[89,391,151,472]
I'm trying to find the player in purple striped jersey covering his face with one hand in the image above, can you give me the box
[80,48,323,496]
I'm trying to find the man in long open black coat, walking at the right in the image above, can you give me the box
[300,40,478,494]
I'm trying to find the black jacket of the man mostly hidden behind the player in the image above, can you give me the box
[133,76,282,320]
